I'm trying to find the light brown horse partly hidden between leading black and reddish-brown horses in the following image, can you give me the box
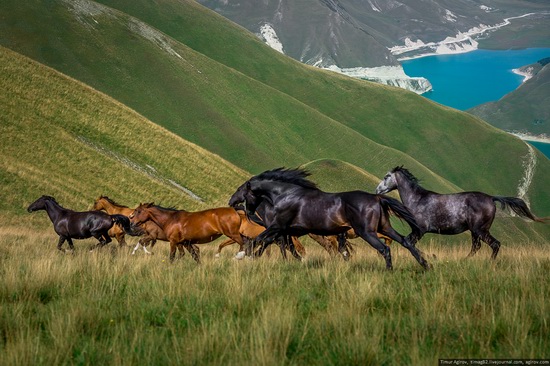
[93,196,199,255]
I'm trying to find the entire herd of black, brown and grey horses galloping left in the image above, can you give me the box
[28,167,547,269]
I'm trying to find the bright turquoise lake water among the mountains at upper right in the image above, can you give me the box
[402,48,550,157]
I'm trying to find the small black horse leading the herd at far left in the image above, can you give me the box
[27,196,133,251]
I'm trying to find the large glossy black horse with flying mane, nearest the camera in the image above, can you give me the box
[229,168,429,269]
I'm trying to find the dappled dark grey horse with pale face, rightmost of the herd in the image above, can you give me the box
[376,167,543,259]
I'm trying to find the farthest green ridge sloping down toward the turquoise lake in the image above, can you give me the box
[85,0,550,197]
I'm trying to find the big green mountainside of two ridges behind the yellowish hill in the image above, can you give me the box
[0,0,550,214]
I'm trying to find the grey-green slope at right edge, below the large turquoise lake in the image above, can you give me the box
[468,58,550,137]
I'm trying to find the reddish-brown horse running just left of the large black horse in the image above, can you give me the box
[128,203,244,263]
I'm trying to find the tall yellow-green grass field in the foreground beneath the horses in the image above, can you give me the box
[0,227,550,365]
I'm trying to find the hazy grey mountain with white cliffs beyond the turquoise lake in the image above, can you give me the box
[198,0,550,93]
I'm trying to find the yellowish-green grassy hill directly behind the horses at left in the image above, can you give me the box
[0,48,248,225]
